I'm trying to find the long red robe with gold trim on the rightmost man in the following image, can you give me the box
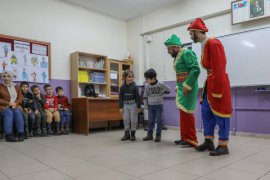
[201,38,232,118]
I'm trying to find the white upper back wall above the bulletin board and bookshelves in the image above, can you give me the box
[0,0,127,80]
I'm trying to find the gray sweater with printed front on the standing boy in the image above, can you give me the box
[143,80,171,105]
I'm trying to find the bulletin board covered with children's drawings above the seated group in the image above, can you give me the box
[0,34,51,83]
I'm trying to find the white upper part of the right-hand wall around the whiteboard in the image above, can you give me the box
[128,0,270,83]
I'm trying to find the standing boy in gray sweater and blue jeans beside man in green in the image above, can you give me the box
[143,69,170,142]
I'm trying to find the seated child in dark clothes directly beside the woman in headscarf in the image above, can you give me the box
[20,81,37,139]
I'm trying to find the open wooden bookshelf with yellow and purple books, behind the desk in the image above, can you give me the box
[70,52,109,98]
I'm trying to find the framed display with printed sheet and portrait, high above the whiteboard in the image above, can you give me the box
[232,0,270,24]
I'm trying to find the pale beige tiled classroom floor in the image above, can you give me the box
[0,130,270,180]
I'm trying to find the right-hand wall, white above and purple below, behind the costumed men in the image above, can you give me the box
[128,0,270,134]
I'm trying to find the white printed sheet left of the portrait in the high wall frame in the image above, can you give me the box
[232,0,249,24]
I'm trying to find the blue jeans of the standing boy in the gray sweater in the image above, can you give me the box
[148,104,163,134]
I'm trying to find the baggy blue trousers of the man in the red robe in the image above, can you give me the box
[201,91,230,141]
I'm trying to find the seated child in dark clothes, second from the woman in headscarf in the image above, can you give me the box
[31,85,47,136]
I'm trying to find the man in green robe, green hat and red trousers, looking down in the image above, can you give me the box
[164,34,200,147]
